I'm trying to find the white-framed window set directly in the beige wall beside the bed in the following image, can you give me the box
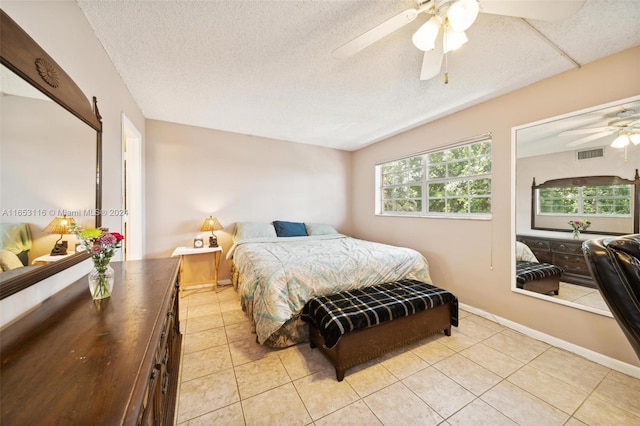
[376,135,491,216]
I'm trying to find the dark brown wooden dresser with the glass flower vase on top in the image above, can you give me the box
[0,258,182,426]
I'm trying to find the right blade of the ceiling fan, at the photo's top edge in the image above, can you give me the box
[480,0,586,21]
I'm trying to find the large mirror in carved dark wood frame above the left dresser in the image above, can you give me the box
[0,11,102,299]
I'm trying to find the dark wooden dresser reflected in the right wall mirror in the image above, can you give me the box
[516,235,596,288]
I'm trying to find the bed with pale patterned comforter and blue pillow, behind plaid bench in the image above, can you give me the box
[227,221,431,348]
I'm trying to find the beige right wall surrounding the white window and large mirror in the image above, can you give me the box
[352,48,640,365]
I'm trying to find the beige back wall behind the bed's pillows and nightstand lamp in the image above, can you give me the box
[145,120,351,281]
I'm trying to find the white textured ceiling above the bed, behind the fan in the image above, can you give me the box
[78,0,640,150]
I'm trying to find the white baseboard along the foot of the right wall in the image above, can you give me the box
[460,303,640,379]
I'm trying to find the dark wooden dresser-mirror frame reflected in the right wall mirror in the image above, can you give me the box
[531,169,640,235]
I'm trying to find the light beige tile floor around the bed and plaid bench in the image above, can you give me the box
[176,286,640,426]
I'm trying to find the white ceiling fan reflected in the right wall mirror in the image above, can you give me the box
[560,109,640,148]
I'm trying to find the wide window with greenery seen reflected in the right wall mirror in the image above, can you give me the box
[538,185,633,217]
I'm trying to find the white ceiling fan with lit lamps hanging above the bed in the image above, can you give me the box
[333,0,586,84]
